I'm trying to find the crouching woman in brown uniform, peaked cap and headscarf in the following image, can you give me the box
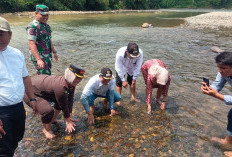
[23,64,85,139]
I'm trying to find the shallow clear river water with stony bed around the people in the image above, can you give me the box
[2,12,232,156]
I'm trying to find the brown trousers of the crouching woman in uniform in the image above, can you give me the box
[23,95,54,124]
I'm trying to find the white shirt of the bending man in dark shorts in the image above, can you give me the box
[115,46,143,81]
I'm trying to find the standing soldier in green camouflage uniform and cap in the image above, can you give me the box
[26,4,58,75]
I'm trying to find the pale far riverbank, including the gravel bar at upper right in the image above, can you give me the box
[0,9,232,29]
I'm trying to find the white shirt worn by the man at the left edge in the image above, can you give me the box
[0,46,28,106]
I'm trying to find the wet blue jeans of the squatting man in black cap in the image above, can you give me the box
[81,90,122,112]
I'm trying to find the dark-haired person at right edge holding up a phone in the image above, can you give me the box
[201,51,232,147]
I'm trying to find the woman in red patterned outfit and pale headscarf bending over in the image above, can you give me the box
[141,59,171,114]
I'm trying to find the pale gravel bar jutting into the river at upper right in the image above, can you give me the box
[185,12,232,29]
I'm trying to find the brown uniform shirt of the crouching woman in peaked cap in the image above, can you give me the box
[31,75,75,118]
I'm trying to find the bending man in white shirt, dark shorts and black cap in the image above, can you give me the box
[115,43,143,102]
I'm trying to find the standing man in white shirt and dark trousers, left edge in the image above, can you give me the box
[0,17,37,157]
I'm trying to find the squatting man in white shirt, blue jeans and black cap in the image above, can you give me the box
[81,68,121,124]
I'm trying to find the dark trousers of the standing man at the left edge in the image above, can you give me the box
[0,102,26,157]
